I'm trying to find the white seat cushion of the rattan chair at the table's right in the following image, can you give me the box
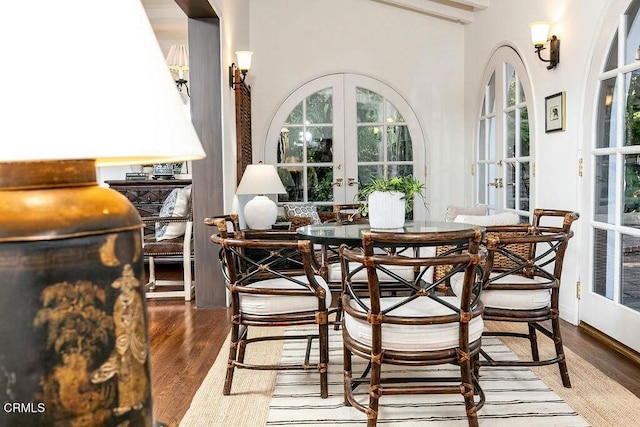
[451,273,551,310]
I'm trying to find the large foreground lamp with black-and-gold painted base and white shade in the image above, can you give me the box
[0,0,205,426]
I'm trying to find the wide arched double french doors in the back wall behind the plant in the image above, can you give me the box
[265,74,426,218]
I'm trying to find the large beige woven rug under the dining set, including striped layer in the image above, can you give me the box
[180,329,640,427]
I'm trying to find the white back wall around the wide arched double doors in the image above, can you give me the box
[247,0,465,218]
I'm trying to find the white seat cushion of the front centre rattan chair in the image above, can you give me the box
[344,297,484,351]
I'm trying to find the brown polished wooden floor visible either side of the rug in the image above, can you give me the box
[147,278,640,426]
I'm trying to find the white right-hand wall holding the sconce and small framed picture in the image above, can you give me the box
[465,0,616,323]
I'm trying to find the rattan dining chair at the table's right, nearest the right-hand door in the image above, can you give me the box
[452,209,579,387]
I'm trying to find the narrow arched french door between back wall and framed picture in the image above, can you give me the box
[473,46,534,218]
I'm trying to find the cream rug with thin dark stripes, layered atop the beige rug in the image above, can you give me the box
[266,330,589,427]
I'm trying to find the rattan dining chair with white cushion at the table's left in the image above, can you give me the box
[211,222,331,398]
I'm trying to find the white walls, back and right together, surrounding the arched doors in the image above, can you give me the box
[211,0,629,322]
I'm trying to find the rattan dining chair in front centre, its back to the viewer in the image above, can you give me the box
[340,228,485,427]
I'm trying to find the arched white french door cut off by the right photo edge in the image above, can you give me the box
[580,0,640,351]
